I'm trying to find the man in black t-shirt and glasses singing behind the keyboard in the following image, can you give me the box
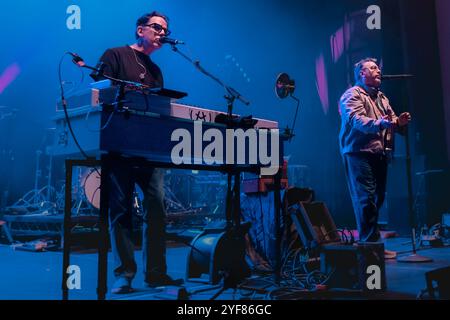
[92,11,183,294]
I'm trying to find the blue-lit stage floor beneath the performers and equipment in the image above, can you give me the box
[0,238,450,300]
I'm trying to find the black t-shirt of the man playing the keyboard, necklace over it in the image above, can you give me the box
[91,46,164,88]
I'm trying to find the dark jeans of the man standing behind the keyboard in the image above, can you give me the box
[109,160,167,281]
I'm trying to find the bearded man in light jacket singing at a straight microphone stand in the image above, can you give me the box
[339,58,411,258]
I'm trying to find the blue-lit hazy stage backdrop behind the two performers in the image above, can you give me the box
[0,0,449,234]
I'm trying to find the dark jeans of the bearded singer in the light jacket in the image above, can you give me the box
[344,152,387,242]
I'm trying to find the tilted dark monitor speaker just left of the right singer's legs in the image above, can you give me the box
[288,202,341,249]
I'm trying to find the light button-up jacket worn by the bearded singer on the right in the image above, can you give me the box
[339,86,397,155]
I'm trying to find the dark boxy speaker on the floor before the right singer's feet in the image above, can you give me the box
[320,242,387,293]
